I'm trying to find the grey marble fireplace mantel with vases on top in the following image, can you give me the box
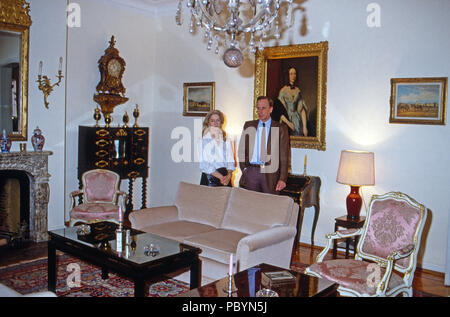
[0,151,53,242]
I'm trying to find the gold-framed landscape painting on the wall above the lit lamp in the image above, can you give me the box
[389,77,448,125]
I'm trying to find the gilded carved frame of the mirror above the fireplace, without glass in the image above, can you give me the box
[0,0,31,141]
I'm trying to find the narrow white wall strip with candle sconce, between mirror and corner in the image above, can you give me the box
[21,0,66,229]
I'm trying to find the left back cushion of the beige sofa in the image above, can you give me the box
[175,182,231,228]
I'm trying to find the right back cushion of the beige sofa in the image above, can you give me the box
[220,188,294,234]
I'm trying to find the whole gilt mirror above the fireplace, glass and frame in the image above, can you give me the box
[0,0,31,141]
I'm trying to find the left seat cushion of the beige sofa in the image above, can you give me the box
[140,220,216,242]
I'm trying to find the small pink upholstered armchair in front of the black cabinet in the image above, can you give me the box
[70,169,127,226]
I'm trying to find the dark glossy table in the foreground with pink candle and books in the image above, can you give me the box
[179,263,338,297]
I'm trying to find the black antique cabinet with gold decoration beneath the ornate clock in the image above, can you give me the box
[78,126,149,213]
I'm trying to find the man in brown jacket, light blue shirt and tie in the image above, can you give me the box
[239,96,290,194]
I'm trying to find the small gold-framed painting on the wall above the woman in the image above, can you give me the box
[183,82,216,117]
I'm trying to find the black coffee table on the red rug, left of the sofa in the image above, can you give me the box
[48,222,201,297]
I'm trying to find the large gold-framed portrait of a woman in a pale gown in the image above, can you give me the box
[253,42,328,151]
